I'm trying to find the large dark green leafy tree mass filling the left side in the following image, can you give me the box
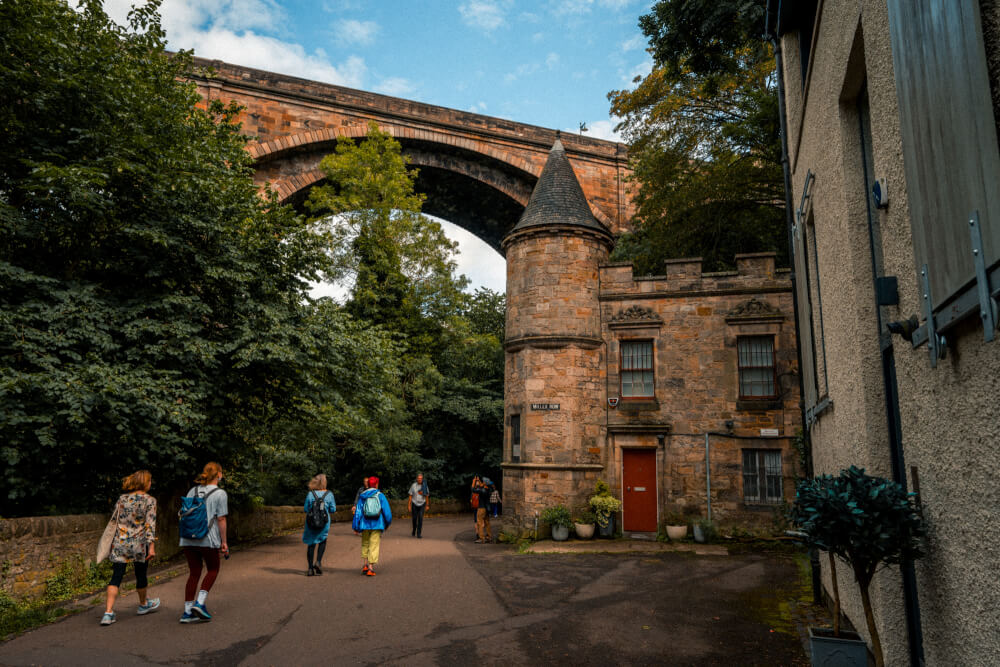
[0,0,398,515]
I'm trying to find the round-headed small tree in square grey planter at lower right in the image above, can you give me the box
[792,466,926,667]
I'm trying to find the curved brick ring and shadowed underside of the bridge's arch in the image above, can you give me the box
[249,126,614,252]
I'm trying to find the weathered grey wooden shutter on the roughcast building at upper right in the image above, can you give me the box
[888,0,1000,318]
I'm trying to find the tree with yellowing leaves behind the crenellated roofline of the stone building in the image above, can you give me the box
[608,0,787,273]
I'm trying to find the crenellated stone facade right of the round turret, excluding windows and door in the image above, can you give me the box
[601,253,801,530]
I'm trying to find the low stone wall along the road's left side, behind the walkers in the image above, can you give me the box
[0,499,468,598]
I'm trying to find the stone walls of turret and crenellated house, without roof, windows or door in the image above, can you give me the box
[503,252,801,532]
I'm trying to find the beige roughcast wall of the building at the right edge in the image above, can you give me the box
[781,0,1000,665]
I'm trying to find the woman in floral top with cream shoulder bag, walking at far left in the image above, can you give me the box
[101,470,160,625]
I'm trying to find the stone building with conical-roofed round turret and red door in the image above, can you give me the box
[502,140,800,533]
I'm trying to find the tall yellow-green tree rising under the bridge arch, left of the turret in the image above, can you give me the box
[307,128,504,493]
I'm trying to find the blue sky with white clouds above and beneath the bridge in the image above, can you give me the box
[99,0,651,290]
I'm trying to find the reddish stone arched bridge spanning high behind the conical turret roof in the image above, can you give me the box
[191,58,633,251]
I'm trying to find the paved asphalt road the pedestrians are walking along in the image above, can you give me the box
[0,517,808,665]
